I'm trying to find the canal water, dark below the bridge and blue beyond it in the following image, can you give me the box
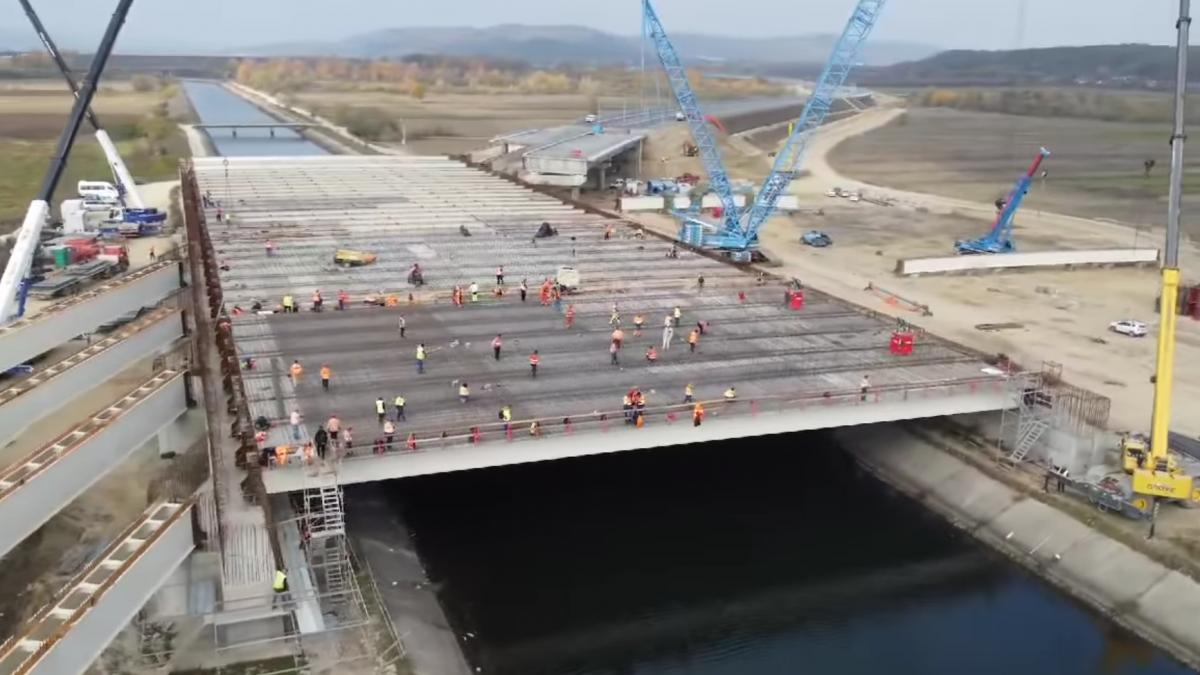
[186,83,1190,675]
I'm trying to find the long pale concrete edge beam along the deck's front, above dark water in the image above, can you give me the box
[263,380,1015,494]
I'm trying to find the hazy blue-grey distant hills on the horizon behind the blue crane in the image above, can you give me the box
[238,24,937,66]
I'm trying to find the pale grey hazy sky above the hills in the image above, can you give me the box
[0,0,1178,53]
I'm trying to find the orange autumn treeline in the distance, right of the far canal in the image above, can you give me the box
[234,55,787,98]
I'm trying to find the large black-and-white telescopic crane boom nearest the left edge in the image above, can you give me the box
[0,0,133,323]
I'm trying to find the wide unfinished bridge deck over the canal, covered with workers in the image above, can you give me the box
[194,151,1022,492]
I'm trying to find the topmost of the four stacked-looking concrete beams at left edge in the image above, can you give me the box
[0,261,179,371]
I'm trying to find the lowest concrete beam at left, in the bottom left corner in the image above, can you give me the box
[0,501,194,675]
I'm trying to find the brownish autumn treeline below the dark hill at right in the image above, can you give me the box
[910,88,1200,124]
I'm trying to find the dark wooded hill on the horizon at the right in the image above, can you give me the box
[858,44,1200,89]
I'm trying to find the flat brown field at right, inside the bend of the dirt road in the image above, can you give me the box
[829,108,1200,234]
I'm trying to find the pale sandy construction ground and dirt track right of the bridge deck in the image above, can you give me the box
[636,99,1200,435]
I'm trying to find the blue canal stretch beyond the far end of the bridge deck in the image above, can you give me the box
[184,80,326,157]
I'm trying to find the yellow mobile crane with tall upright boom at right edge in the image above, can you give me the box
[1121,0,1200,518]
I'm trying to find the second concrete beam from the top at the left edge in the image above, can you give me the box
[0,307,184,446]
